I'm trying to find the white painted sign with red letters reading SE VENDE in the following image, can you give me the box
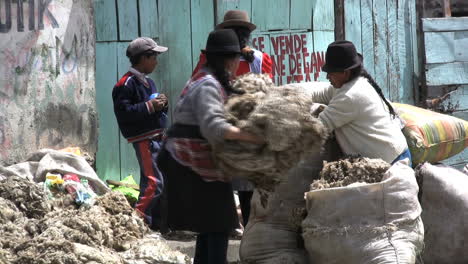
[252,33,325,85]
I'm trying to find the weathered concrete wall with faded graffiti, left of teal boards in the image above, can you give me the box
[0,0,98,164]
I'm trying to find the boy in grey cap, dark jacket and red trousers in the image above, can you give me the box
[112,37,168,229]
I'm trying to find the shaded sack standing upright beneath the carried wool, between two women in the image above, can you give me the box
[239,141,338,264]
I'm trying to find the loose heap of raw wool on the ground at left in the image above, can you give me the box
[0,176,189,264]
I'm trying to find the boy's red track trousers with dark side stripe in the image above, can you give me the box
[133,139,164,227]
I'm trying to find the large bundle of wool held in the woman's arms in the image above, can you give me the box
[214,74,328,190]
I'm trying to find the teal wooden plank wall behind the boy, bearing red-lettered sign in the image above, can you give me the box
[94,0,335,180]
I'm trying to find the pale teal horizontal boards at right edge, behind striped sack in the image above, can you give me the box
[422,17,468,166]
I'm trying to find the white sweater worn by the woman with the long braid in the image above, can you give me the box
[303,77,408,163]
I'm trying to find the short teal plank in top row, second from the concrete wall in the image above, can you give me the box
[117,0,139,41]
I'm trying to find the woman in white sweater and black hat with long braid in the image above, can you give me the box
[305,40,411,163]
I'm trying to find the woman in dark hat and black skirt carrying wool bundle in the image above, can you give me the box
[158,29,262,264]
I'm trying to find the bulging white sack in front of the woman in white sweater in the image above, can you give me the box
[302,161,424,264]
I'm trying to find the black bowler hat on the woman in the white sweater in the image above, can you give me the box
[322,40,362,72]
